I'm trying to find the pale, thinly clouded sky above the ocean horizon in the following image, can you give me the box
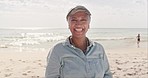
[0,0,148,29]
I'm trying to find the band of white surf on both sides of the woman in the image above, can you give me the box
[0,32,147,47]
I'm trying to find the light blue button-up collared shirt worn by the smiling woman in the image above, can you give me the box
[45,38,112,78]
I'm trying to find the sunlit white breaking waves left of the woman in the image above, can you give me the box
[0,33,65,46]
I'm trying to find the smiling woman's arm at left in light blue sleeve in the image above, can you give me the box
[45,49,60,78]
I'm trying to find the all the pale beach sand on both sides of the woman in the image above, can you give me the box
[0,44,148,78]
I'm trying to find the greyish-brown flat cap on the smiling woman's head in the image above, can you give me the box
[66,6,91,20]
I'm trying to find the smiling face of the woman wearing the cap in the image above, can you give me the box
[68,12,90,38]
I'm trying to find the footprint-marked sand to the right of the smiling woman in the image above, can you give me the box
[106,48,148,78]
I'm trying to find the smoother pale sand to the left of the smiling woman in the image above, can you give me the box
[0,52,47,78]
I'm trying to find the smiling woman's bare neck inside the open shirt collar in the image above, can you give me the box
[70,37,88,52]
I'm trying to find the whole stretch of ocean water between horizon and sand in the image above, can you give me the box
[0,28,148,52]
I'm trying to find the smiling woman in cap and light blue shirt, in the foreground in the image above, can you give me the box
[45,6,112,78]
